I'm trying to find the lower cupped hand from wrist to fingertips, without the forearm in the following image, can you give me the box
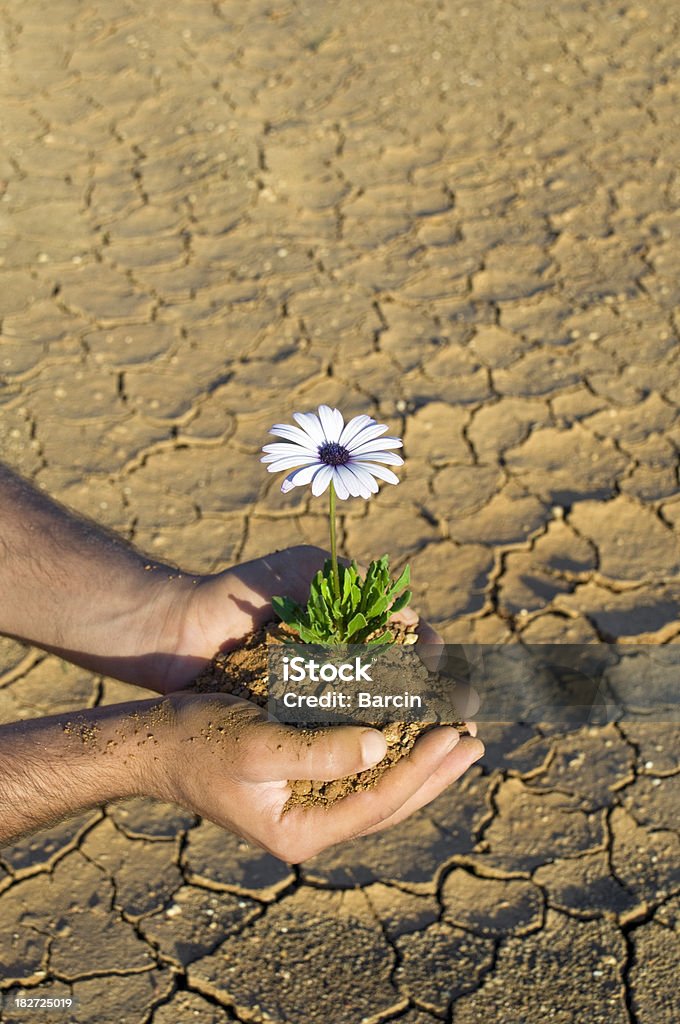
[156,692,483,863]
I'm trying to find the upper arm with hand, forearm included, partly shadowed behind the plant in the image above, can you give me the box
[0,463,446,693]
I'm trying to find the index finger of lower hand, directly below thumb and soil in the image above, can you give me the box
[279,727,462,860]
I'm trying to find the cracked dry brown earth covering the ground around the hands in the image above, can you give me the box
[0,0,680,1024]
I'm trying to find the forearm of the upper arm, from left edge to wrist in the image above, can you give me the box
[0,465,196,685]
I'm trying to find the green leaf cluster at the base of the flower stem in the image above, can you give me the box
[271,555,411,646]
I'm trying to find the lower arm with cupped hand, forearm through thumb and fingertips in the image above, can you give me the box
[0,692,483,862]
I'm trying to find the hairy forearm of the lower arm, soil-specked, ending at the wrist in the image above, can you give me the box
[0,698,168,846]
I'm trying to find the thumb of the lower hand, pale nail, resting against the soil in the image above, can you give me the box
[240,722,387,782]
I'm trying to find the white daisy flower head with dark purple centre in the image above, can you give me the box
[260,406,403,500]
